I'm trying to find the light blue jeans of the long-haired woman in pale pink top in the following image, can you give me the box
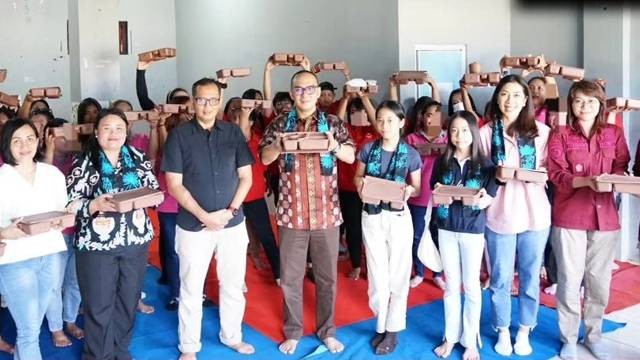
[485,228,549,328]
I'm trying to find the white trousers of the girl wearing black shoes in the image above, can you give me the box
[362,210,413,333]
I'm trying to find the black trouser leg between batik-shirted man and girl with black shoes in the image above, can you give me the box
[338,191,362,268]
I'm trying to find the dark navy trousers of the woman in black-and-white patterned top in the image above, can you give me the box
[76,243,149,360]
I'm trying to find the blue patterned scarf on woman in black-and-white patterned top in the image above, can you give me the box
[100,146,141,194]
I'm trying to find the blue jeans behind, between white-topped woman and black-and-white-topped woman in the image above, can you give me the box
[45,234,81,332]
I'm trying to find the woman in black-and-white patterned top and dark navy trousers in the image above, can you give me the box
[67,109,158,359]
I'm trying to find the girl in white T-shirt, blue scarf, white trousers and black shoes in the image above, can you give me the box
[354,101,422,355]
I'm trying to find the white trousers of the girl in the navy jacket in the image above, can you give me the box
[438,229,484,348]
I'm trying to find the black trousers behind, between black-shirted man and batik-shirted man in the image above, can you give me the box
[242,198,280,279]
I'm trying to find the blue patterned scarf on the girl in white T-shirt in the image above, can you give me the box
[364,140,409,215]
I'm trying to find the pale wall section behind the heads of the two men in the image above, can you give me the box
[176,0,398,99]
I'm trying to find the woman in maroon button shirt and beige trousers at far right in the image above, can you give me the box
[548,81,630,359]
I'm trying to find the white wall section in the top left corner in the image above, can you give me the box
[0,0,71,117]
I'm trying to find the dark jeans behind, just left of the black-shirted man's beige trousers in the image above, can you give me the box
[158,212,180,300]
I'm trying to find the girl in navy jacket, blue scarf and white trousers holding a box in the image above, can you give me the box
[431,111,498,360]
